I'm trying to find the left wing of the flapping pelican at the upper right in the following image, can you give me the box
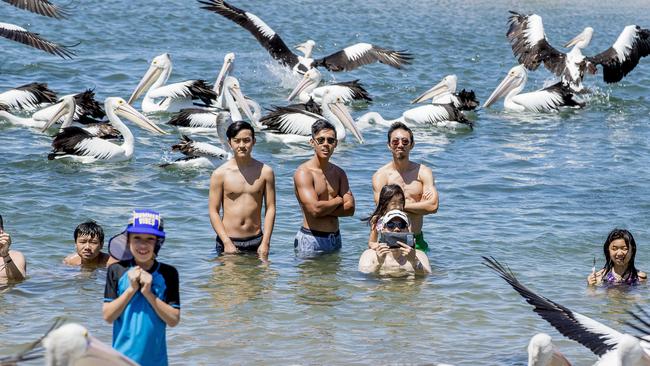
[506,11,566,76]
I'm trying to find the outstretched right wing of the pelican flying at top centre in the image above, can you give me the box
[314,43,413,71]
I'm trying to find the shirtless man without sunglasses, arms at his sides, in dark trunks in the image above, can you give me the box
[208,121,275,260]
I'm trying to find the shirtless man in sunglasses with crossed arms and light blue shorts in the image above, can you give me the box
[293,120,354,256]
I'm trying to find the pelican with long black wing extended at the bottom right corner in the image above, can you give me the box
[483,257,650,366]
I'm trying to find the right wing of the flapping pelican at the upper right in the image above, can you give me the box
[587,25,650,83]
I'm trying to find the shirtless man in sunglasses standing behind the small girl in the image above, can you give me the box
[372,122,438,251]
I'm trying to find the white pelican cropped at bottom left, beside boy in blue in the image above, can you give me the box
[0,320,137,366]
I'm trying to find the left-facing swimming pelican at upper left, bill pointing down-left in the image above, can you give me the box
[128,53,217,113]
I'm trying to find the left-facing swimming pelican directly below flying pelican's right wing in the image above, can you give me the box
[287,69,372,104]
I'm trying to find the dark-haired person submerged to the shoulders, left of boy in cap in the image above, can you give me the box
[63,220,117,268]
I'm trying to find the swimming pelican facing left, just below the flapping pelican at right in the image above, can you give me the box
[483,65,584,112]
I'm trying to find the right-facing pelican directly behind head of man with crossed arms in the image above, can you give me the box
[260,92,363,144]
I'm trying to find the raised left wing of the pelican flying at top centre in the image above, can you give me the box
[199,0,298,67]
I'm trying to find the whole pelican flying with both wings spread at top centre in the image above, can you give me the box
[198,0,412,74]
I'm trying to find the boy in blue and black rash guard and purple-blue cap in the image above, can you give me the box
[102,210,181,366]
